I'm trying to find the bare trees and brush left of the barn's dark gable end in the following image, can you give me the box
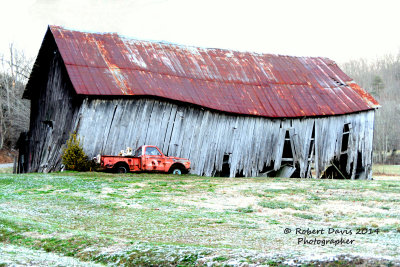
[0,44,33,149]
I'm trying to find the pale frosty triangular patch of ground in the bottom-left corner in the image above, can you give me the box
[0,244,103,266]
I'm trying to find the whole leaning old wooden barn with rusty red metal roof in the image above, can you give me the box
[18,26,379,179]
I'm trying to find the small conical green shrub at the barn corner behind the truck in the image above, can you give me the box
[62,133,91,171]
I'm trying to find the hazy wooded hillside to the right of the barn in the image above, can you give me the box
[341,52,400,164]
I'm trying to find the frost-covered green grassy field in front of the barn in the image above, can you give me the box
[0,172,400,266]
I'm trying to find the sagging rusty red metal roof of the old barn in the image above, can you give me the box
[38,26,379,117]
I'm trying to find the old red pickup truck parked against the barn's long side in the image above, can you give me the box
[94,145,190,174]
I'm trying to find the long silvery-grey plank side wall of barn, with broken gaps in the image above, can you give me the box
[76,99,374,179]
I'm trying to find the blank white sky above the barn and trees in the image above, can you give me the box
[0,0,400,63]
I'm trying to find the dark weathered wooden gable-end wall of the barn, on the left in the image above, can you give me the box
[19,51,82,172]
